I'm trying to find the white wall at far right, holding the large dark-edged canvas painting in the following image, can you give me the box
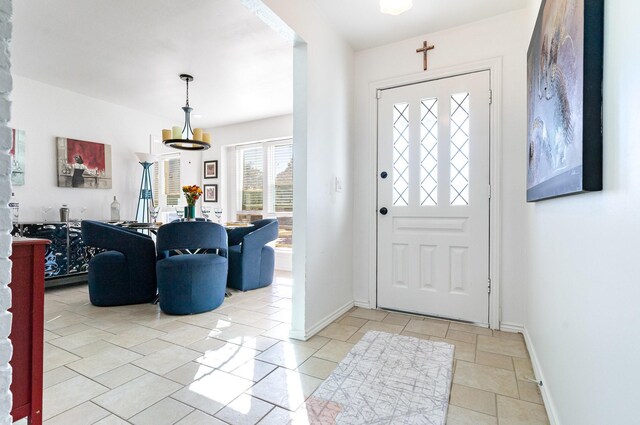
[520,0,640,425]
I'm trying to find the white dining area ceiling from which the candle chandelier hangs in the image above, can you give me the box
[11,0,293,127]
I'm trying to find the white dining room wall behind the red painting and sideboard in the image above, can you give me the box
[9,75,171,221]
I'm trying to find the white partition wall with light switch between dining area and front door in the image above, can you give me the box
[264,0,353,338]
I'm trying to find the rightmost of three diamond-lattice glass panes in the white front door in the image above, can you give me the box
[450,93,469,205]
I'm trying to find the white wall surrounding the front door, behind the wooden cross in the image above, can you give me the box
[353,10,528,325]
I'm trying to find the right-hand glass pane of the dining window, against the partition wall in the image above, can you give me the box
[269,144,293,212]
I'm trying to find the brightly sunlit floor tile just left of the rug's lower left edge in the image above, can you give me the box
[247,368,322,410]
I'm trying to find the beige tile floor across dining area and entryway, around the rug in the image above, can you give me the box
[17,273,549,425]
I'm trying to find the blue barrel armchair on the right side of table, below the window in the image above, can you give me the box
[227,218,278,291]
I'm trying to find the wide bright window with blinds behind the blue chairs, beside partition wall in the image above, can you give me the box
[236,139,293,248]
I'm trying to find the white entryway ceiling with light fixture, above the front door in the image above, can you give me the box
[314,0,530,51]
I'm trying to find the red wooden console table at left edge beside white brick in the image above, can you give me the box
[9,238,49,425]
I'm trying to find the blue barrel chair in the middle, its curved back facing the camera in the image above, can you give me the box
[156,221,229,314]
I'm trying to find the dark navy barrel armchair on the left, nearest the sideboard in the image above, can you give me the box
[81,220,157,307]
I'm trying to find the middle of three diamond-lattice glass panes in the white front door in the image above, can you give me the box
[420,98,438,206]
